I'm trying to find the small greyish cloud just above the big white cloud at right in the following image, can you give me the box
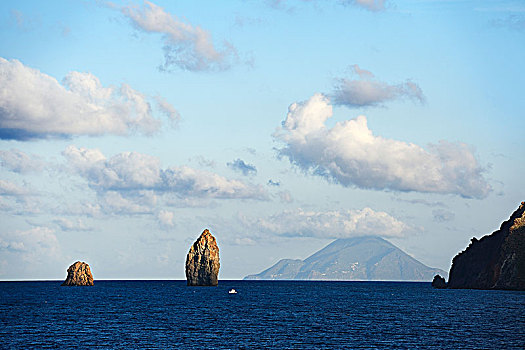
[332,64,425,108]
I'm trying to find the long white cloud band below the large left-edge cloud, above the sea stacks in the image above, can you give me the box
[63,146,268,205]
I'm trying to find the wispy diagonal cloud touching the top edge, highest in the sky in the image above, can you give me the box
[121,1,237,71]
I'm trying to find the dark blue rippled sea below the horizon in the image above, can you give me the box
[0,280,525,349]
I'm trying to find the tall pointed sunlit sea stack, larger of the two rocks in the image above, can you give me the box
[186,229,221,286]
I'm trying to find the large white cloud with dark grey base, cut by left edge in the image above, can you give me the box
[0,57,172,140]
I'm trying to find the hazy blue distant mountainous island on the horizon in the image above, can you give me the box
[244,236,447,282]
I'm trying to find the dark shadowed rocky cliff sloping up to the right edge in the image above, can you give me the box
[448,202,525,290]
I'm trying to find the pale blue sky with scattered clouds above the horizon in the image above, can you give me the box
[0,0,525,280]
